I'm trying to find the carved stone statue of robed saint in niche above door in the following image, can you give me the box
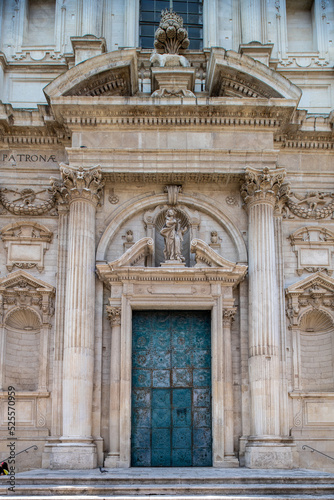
[160,208,187,262]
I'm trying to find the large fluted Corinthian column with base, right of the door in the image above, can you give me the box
[241,167,292,468]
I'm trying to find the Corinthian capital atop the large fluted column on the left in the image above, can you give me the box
[60,163,104,205]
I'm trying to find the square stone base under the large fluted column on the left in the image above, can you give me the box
[49,443,97,470]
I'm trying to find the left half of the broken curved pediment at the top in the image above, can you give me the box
[44,49,138,100]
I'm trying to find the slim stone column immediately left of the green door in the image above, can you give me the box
[104,306,121,467]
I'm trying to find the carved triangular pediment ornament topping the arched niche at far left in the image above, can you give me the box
[0,271,55,326]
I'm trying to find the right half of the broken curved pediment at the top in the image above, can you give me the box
[206,48,302,104]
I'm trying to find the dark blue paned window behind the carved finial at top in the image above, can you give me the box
[139,0,203,50]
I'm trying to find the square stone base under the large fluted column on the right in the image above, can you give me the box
[245,439,294,469]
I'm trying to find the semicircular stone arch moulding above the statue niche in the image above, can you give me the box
[96,194,247,263]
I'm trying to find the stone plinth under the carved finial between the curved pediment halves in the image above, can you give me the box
[151,66,196,97]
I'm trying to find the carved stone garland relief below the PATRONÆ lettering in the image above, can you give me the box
[0,188,57,216]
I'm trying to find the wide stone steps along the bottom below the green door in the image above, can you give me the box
[0,468,334,500]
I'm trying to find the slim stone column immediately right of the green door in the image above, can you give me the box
[223,307,238,464]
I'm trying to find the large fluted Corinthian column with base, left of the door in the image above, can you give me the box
[51,165,103,469]
